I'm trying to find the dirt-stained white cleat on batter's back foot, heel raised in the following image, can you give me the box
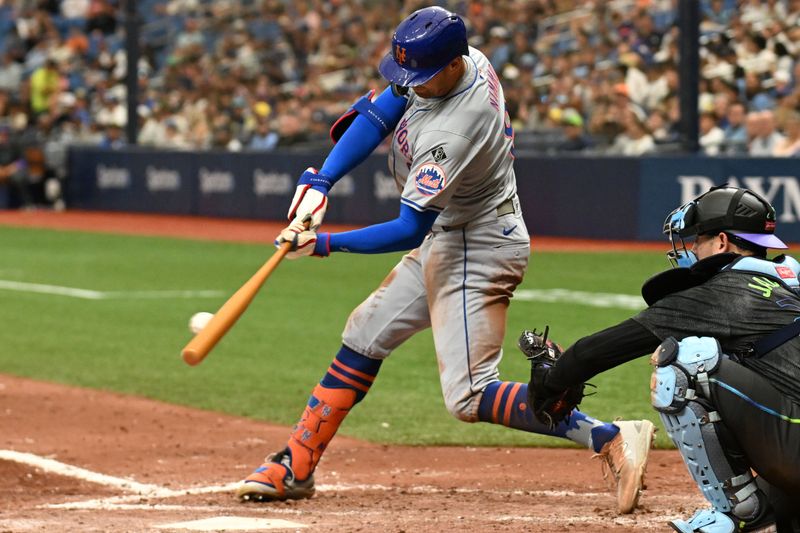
[595,420,656,514]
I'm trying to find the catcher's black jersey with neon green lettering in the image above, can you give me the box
[634,270,800,402]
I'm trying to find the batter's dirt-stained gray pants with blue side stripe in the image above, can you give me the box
[342,201,530,422]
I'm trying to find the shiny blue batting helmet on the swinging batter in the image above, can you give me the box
[378,6,469,87]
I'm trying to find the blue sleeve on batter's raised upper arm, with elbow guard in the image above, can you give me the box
[320,86,408,186]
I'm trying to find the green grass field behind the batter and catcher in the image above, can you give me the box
[0,227,667,446]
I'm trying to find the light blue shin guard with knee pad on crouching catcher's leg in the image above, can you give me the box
[650,337,764,521]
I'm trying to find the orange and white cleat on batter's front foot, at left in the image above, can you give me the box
[236,449,314,502]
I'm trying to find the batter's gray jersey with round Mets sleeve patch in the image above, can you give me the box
[389,48,517,226]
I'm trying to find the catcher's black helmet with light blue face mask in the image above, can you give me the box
[664,185,788,267]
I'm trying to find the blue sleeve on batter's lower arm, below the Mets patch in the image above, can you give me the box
[314,204,439,256]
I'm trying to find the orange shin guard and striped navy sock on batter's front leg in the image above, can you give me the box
[288,346,382,480]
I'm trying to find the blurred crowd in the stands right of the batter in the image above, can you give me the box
[504,0,800,157]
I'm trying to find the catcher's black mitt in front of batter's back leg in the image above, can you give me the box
[518,326,585,429]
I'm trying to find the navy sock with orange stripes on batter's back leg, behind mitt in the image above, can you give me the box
[478,381,619,453]
